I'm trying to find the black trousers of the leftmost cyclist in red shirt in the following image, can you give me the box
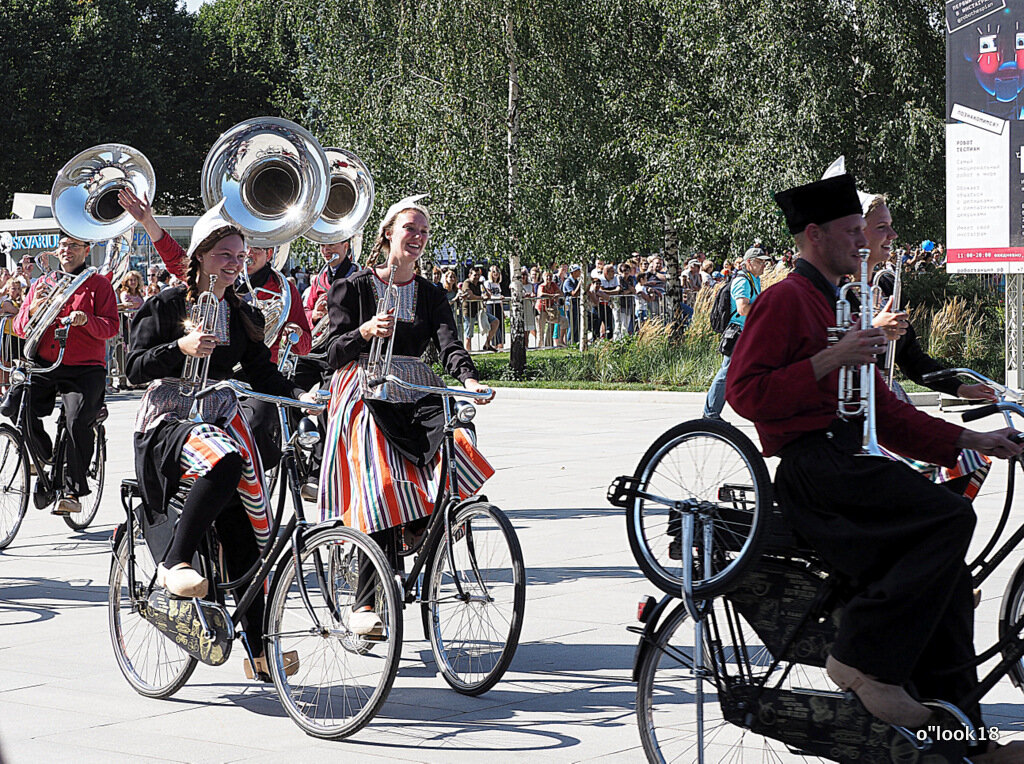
[25,366,106,497]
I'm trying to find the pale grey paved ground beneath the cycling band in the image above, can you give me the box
[0,390,1024,764]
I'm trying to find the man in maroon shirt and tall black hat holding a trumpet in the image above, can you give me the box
[726,175,1022,745]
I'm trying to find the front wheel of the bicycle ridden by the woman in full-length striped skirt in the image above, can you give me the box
[425,502,526,695]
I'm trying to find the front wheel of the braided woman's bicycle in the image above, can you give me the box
[266,526,402,739]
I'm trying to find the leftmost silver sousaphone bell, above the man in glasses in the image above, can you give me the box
[50,143,157,242]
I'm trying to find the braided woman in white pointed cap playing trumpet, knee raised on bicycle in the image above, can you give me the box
[127,205,311,681]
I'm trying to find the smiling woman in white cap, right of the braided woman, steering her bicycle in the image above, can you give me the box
[317,197,494,635]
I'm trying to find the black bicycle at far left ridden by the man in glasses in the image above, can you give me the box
[0,319,106,549]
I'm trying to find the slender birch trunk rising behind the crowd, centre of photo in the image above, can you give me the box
[505,5,526,379]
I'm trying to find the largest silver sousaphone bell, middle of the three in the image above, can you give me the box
[201,117,329,247]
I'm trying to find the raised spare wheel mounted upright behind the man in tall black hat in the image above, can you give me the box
[626,419,772,597]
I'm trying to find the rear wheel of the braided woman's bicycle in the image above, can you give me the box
[106,520,197,697]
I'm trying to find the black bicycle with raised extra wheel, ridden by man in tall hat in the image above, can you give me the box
[608,407,1024,764]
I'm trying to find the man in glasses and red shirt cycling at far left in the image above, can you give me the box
[14,234,120,514]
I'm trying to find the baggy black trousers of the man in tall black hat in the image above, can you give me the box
[775,424,981,724]
